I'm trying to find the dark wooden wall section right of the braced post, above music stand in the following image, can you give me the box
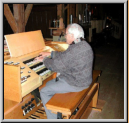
[25,4,57,38]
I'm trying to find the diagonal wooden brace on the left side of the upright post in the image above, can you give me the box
[4,4,17,33]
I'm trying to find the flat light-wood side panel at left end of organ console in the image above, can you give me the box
[4,65,22,102]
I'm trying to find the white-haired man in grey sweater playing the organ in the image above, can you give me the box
[35,23,93,119]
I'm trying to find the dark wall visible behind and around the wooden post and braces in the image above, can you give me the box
[3,4,57,38]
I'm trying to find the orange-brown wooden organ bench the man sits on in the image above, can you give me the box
[46,70,105,119]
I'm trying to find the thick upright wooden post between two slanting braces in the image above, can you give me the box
[13,4,25,33]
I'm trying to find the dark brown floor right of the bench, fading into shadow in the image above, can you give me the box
[88,37,124,119]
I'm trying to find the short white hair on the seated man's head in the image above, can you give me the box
[67,23,84,39]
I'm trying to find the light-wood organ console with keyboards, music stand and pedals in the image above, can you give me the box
[4,30,68,119]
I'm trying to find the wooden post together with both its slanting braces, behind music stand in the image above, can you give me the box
[4,4,33,33]
